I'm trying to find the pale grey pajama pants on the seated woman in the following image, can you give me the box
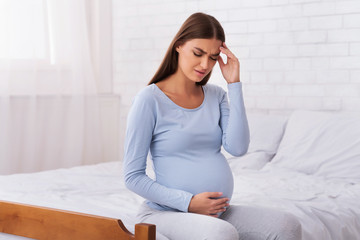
[138,203,301,240]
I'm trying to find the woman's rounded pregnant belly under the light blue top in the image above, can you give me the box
[155,154,234,201]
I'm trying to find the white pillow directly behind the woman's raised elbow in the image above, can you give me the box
[222,114,287,169]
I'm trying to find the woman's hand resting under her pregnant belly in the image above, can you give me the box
[188,192,229,217]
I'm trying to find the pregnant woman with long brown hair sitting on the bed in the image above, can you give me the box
[124,13,301,240]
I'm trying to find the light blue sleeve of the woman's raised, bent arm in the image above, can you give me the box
[220,82,250,156]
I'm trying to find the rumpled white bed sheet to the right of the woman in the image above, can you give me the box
[232,167,360,240]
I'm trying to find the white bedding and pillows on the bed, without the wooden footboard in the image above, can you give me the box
[0,111,360,240]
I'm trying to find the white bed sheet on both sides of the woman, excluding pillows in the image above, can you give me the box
[0,159,360,240]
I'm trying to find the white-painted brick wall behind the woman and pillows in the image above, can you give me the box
[113,0,360,150]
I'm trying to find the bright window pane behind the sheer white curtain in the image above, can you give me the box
[0,0,49,60]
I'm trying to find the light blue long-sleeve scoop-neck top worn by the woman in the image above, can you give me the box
[123,82,249,212]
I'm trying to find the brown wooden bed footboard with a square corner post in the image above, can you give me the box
[0,201,156,240]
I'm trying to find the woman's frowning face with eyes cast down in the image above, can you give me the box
[176,38,222,82]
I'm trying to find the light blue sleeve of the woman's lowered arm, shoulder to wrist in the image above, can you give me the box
[123,92,193,212]
